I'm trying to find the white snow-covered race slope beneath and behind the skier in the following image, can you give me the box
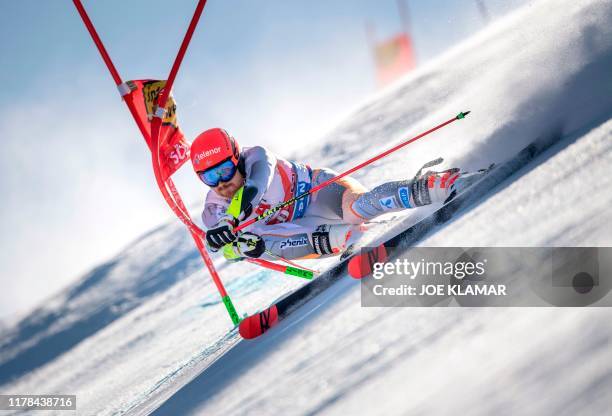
[0,0,612,414]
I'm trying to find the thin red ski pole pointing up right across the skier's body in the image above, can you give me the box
[234,111,470,232]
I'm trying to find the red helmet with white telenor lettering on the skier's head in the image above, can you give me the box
[191,128,240,172]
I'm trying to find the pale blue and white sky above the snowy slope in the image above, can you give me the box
[0,0,524,318]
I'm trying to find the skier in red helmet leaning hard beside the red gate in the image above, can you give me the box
[191,128,461,260]
